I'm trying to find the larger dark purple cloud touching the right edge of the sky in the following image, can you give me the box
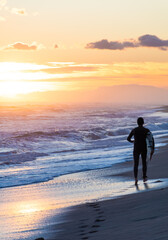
[138,34,168,50]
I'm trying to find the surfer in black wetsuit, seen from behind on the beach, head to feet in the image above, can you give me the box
[127,117,154,185]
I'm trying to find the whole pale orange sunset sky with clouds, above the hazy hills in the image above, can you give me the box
[0,0,168,101]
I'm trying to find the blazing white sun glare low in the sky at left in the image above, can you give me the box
[0,62,68,98]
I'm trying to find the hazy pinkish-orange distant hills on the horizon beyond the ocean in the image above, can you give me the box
[8,85,168,104]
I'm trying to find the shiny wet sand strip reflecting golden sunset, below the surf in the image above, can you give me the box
[0,170,167,240]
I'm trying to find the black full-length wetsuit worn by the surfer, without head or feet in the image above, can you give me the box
[127,126,149,179]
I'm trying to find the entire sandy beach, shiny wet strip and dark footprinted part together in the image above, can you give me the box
[0,144,168,240]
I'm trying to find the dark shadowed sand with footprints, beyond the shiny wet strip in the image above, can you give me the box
[53,144,168,240]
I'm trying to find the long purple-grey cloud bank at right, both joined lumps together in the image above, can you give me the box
[85,34,168,51]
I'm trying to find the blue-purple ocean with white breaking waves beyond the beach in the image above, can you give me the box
[0,104,168,188]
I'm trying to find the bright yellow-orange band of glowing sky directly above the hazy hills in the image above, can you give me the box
[0,62,168,97]
